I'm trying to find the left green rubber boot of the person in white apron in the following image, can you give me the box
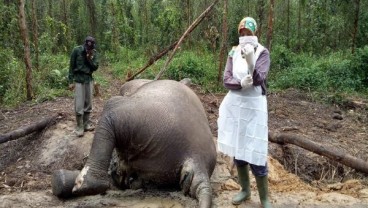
[232,165,250,205]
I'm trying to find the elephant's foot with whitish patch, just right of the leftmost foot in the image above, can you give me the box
[72,166,110,196]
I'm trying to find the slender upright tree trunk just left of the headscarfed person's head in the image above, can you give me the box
[217,0,228,85]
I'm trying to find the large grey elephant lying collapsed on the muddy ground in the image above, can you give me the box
[52,79,217,208]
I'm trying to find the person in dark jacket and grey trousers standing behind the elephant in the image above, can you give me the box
[68,36,99,137]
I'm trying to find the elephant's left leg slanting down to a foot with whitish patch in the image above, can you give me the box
[73,117,115,195]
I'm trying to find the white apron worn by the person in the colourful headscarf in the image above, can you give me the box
[217,45,268,166]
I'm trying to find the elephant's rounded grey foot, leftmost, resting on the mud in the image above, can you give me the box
[51,170,79,198]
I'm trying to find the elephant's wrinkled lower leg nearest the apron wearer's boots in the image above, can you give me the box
[180,159,212,208]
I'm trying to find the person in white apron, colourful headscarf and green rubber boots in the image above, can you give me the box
[217,17,271,208]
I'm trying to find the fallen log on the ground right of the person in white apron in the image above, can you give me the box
[268,133,368,173]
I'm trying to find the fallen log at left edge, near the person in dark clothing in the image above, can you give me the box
[0,114,61,144]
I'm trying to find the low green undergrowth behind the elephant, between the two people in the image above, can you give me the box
[108,47,223,91]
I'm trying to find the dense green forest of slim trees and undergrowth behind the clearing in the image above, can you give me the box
[0,0,368,107]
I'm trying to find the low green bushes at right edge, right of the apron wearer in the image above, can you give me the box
[269,47,368,103]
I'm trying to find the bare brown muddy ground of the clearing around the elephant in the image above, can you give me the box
[0,72,368,208]
